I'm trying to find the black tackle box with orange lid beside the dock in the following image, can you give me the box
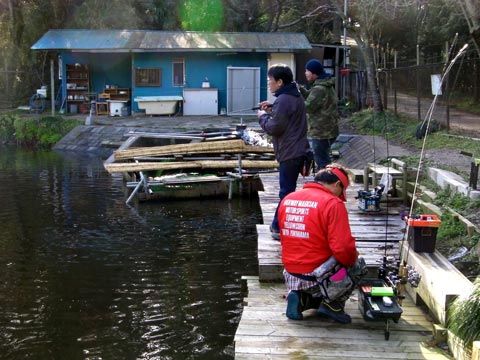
[407,214,442,253]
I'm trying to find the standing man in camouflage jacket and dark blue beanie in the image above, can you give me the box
[300,59,339,172]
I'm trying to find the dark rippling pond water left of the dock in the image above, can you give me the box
[0,148,262,359]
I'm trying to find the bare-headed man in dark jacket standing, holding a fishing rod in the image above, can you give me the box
[257,64,313,240]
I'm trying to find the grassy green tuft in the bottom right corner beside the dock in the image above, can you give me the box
[448,278,480,348]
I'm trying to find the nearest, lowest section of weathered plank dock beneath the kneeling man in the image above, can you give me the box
[234,277,451,360]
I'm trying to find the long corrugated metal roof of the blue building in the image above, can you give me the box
[31,29,312,52]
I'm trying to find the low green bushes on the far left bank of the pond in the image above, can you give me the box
[9,116,79,148]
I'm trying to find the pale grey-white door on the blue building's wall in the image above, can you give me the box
[227,66,260,115]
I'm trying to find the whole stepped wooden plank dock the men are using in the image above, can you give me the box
[234,174,452,360]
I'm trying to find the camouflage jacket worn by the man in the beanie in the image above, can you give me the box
[300,78,339,139]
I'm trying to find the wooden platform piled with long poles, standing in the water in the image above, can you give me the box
[104,126,278,204]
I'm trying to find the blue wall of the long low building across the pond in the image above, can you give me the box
[62,52,268,112]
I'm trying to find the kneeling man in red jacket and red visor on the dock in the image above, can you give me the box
[278,164,365,324]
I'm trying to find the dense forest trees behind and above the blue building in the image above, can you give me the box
[0,0,480,112]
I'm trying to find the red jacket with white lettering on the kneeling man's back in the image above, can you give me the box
[278,182,357,274]
